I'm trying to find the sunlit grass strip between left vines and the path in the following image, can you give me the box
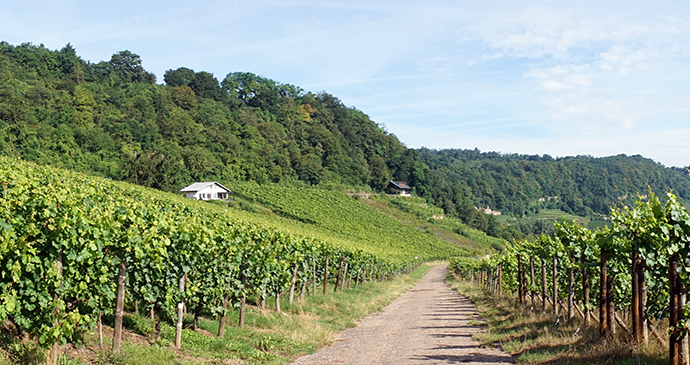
[0,263,434,365]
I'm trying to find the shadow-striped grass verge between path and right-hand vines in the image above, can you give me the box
[446,274,668,365]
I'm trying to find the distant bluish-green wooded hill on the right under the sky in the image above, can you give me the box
[420,149,690,217]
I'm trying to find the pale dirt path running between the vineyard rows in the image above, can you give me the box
[293,266,514,365]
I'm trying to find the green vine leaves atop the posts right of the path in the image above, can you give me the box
[451,192,690,336]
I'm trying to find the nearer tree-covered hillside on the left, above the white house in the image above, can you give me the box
[0,42,421,191]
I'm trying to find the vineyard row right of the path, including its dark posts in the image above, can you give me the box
[451,193,690,365]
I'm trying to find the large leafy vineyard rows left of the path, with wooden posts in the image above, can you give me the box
[0,158,460,363]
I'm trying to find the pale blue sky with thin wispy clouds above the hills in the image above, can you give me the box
[0,0,690,166]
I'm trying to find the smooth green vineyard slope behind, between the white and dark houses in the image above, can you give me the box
[233,183,468,262]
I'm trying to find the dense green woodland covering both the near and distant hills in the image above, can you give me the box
[0,42,690,239]
